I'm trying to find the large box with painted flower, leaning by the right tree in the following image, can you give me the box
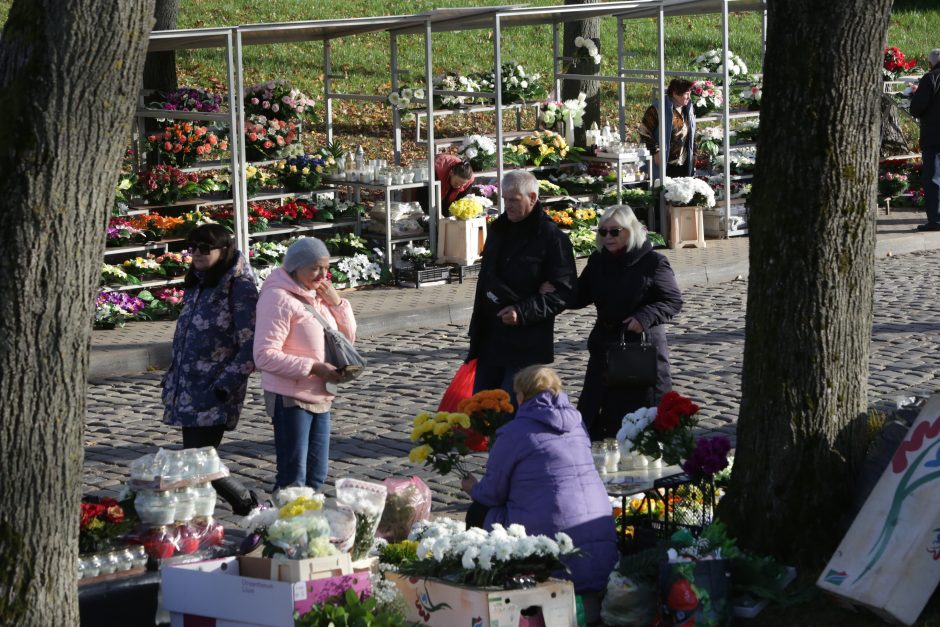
[816,395,940,625]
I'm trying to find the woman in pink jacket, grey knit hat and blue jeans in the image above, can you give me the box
[254,237,356,490]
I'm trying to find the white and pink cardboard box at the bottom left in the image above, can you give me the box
[161,557,372,627]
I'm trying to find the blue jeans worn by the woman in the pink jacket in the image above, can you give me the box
[271,395,330,491]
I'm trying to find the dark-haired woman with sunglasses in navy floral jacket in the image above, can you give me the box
[163,224,258,515]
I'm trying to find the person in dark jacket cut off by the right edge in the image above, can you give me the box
[910,48,940,231]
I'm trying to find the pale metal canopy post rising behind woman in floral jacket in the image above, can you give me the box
[232,29,249,257]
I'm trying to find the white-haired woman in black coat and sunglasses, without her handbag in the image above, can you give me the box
[572,205,682,440]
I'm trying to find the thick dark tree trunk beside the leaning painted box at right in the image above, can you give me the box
[719,0,891,564]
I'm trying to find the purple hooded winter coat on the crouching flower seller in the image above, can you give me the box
[470,392,618,591]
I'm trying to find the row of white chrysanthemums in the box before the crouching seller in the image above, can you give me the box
[398,518,579,587]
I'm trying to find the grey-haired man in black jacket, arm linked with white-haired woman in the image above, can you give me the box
[467,170,577,403]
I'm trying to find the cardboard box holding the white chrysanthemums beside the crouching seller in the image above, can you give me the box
[386,573,578,627]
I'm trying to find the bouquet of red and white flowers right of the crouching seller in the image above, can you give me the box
[617,391,699,464]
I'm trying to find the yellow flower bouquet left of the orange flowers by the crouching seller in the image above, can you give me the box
[408,411,471,476]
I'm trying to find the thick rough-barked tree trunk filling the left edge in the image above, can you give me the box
[0,0,153,625]
